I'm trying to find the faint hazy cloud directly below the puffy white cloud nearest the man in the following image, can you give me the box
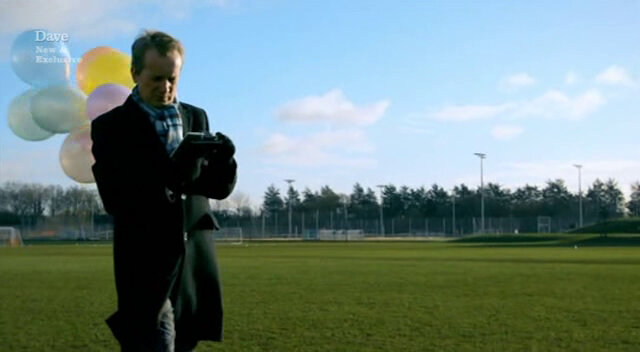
[262,130,376,167]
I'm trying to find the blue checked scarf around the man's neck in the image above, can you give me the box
[131,86,182,155]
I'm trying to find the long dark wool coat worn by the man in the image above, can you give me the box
[91,97,236,343]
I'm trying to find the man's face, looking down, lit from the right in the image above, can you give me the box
[131,49,182,107]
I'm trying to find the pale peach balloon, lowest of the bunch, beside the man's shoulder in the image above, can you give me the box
[60,123,96,183]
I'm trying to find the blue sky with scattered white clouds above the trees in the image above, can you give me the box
[0,0,640,205]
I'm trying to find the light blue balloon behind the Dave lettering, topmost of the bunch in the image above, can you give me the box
[11,29,71,88]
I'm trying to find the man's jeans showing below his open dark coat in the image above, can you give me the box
[122,299,195,352]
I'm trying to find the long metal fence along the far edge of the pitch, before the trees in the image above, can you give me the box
[15,212,590,240]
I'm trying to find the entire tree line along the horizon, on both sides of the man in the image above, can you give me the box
[0,179,640,236]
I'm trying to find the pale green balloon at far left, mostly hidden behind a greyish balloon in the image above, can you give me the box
[8,89,53,141]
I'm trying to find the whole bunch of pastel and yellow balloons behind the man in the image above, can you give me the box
[8,29,134,183]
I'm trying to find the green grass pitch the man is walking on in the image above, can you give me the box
[0,239,640,352]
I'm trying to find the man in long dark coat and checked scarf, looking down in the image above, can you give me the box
[91,31,237,352]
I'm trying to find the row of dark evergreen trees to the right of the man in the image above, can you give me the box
[252,179,640,230]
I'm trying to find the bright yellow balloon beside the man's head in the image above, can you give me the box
[77,46,134,95]
